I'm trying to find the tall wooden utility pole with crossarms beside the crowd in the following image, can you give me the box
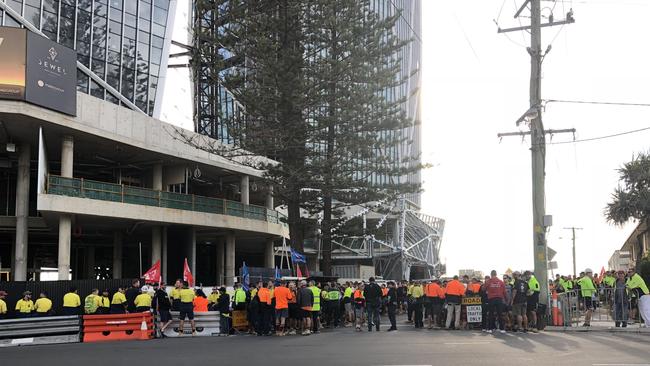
[498,0,575,306]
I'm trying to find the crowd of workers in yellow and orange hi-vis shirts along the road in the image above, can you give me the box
[0,268,650,337]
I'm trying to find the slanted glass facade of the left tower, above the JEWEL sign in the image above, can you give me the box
[0,0,175,115]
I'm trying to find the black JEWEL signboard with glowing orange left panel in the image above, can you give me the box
[0,27,77,116]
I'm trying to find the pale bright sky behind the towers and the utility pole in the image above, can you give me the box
[161,0,650,274]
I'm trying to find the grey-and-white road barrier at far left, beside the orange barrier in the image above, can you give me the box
[0,316,81,347]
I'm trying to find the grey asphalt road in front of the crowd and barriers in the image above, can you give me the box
[0,325,650,366]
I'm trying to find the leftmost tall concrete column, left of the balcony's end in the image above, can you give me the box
[12,143,30,281]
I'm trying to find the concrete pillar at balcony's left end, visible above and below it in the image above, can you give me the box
[58,136,74,280]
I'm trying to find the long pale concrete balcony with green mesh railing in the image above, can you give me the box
[37,175,289,237]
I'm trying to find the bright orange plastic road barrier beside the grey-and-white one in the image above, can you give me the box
[83,312,154,342]
